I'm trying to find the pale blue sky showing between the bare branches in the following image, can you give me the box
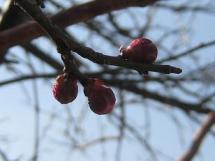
[0,1,215,161]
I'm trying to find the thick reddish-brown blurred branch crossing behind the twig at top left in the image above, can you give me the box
[0,0,158,52]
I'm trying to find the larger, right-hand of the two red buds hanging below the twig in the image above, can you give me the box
[84,79,116,115]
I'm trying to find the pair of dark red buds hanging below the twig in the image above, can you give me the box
[52,74,116,115]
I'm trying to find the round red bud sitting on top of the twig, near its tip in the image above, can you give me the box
[120,37,158,64]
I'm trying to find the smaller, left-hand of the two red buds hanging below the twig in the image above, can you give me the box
[52,74,78,104]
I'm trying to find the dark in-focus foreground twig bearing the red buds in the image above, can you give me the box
[16,0,182,75]
